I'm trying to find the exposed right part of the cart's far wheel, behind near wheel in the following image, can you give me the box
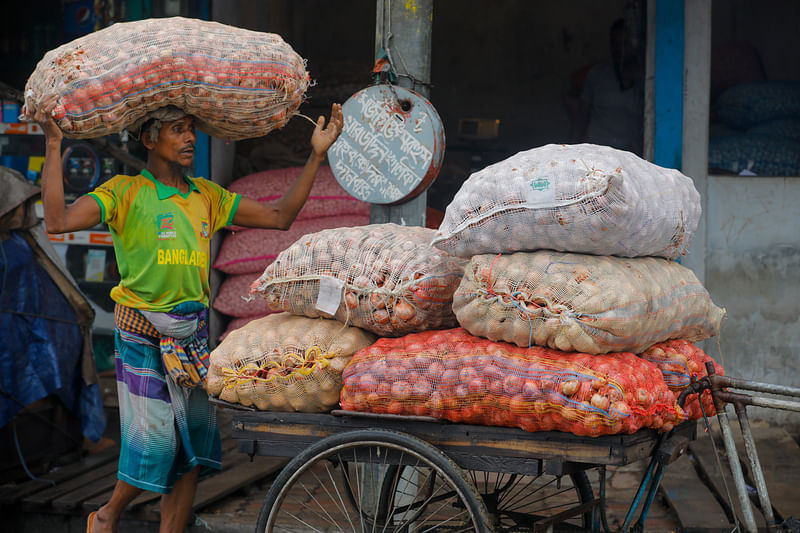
[468,470,594,532]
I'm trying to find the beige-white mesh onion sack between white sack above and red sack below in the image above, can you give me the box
[453,250,725,354]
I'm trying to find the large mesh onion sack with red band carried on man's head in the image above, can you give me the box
[23,17,309,140]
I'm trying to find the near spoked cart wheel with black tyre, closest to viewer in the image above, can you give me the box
[257,429,487,533]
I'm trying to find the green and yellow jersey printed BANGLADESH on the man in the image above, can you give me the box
[89,170,241,312]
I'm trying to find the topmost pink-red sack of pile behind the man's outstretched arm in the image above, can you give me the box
[228,165,369,221]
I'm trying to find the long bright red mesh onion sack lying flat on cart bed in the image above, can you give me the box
[339,328,685,436]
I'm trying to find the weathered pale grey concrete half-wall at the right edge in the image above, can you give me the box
[705,176,800,426]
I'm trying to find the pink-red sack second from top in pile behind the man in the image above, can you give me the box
[211,215,369,274]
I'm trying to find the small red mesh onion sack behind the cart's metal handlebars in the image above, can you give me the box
[639,340,725,420]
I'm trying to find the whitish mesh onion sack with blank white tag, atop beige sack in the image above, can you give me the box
[250,224,465,337]
